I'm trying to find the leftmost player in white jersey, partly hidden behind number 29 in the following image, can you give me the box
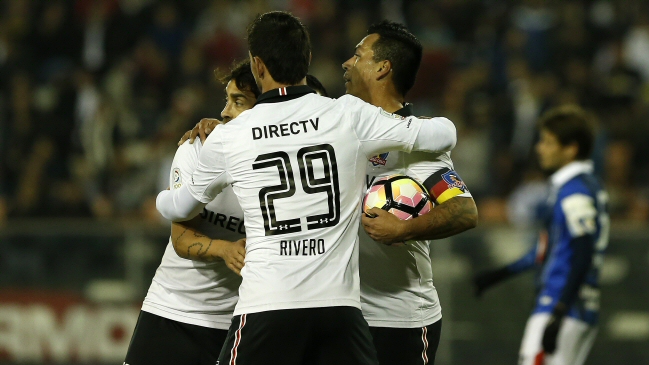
[124,60,259,365]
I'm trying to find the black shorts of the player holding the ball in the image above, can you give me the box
[370,319,442,365]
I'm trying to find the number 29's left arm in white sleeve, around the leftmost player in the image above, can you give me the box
[156,127,232,222]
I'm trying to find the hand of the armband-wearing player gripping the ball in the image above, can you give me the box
[361,208,405,245]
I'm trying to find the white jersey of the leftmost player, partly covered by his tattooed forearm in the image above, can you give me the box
[142,139,245,329]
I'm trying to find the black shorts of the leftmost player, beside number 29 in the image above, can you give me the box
[124,311,228,365]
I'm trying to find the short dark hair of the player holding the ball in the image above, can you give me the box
[367,20,423,96]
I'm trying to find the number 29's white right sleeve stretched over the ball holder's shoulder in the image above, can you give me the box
[338,95,456,158]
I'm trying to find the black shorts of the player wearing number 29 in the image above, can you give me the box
[219,307,378,365]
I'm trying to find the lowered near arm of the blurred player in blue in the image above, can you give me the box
[542,194,597,354]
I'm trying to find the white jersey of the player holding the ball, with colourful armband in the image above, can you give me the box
[359,105,471,328]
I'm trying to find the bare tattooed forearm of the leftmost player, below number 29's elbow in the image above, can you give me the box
[171,217,246,275]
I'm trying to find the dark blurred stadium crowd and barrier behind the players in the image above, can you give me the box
[0,0,649,365]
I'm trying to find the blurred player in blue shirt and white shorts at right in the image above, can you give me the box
[474,106,609,365]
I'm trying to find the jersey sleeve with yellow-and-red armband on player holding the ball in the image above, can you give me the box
[416,153,471,204]
